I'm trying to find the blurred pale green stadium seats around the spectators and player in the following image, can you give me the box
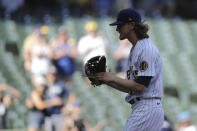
[0,18,197,131]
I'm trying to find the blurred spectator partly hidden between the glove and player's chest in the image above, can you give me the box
[113,39,132,78]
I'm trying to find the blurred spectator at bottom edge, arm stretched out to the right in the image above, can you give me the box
[63,101,108,131]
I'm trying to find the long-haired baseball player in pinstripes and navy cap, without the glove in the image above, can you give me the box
[95,8,164,131]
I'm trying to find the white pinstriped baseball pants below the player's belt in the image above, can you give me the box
[124,100,164,131]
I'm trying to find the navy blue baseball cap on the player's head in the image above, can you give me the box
[109,8,141,26]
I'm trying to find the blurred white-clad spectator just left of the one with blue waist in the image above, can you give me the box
[31,26,51,75]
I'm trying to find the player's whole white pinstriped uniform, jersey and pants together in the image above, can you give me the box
[124,39,164,131]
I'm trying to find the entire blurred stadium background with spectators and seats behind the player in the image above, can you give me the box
[0,0,197,131]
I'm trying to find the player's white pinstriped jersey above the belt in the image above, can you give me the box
[125,38,163,102]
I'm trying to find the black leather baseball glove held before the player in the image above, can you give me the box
[85,56,106,86]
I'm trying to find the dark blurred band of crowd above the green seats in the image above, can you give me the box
[0,0,197,22]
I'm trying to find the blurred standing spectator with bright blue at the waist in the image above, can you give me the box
[50,27,77,87]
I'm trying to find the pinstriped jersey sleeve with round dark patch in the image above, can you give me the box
[137,47,156,76]
